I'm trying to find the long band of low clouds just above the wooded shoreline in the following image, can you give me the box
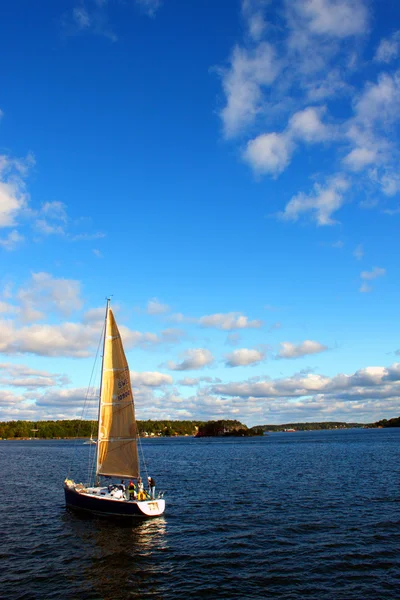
[0,363,400,425]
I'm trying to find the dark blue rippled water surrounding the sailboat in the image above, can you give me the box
[0,429,400,600]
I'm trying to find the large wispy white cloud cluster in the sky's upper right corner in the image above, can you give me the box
[219,0,400,225]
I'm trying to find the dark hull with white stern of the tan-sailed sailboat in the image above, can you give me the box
[64,486,165,519]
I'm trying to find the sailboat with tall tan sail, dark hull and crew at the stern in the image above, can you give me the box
[64,299,165,518]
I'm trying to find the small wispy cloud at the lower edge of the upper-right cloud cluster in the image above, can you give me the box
[279,175,349,225]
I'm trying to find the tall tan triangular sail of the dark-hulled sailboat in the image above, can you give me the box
[96,308,140,478]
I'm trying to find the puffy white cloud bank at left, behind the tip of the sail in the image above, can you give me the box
[0,282,185,358]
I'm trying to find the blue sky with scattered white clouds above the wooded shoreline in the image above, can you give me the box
[0,0,400,426]
